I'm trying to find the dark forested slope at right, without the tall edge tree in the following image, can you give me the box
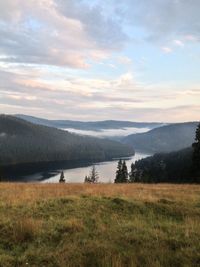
[131,147,197,183]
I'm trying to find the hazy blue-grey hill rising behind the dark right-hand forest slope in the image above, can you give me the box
[122,122,198,153]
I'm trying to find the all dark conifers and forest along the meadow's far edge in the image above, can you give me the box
[56,124,200,183]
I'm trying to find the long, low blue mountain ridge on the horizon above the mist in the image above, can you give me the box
[15,114,162,131]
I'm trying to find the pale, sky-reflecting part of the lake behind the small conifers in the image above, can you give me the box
[36,153,149,183]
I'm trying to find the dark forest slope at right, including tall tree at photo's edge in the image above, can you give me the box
[125,124,200,183]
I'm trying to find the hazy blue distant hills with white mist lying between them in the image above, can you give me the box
[16,115,198,154]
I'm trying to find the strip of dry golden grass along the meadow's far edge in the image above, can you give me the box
[0,183,200,204]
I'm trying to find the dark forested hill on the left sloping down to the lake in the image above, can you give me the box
[0,115,134,166]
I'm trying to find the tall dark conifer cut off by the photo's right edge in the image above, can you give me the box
[192,123,200,180]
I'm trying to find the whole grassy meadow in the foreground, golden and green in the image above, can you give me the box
[0,183,200,267]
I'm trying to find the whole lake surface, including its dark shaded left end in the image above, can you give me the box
[0,152,148,183]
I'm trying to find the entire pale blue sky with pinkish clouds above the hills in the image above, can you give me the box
[0,0,200,122]
